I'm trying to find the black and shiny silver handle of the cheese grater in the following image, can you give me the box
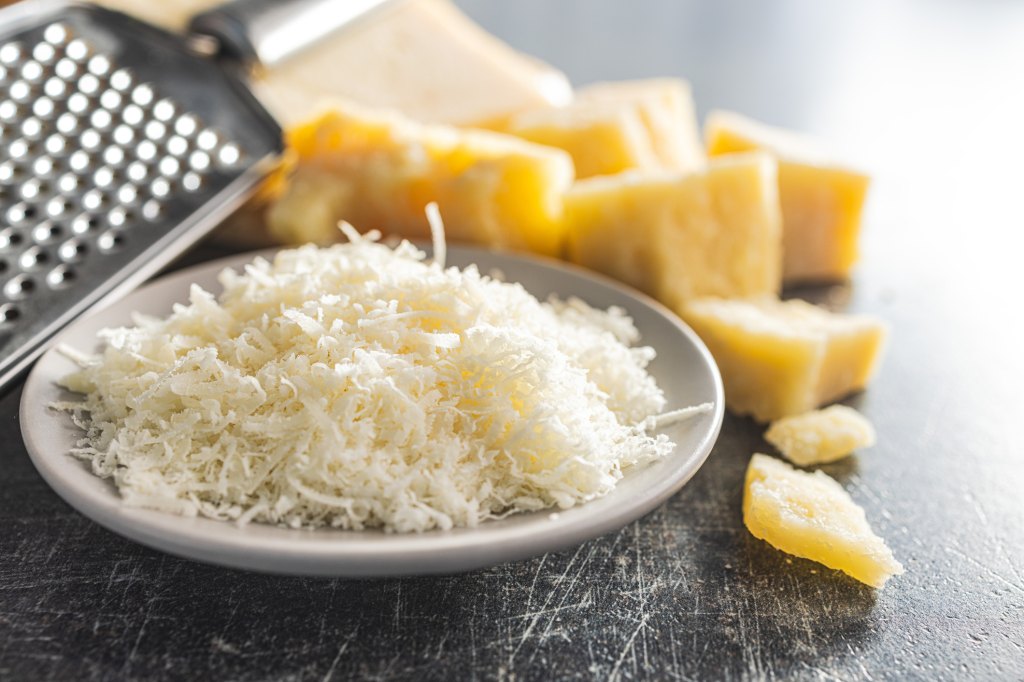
[188,0,396,68]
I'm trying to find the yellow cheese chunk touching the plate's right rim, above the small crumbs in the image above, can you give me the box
[682,297,886,421]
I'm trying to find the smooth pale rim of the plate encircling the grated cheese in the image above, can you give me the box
[18,243,725,578]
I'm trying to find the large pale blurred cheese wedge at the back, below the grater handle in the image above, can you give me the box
[254,0,572,127]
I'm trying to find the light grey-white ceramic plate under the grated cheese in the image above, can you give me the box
[20,247,724,577]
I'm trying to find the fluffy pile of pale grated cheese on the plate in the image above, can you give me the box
[57,226,696,531]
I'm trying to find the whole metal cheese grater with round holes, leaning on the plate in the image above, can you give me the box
[0,0,393,388]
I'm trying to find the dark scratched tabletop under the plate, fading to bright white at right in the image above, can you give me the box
[0,0,1024,680]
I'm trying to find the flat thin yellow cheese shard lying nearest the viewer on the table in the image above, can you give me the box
[743,455,903,588]
